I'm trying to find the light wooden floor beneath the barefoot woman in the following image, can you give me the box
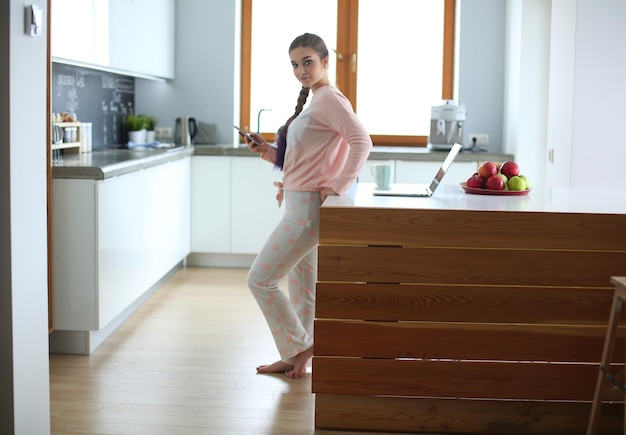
[50,268,398,435]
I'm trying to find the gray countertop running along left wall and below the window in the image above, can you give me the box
[52,145,513,180]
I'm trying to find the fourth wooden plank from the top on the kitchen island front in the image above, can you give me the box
[315,319,626,362]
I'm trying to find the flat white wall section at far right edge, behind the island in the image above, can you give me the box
[570,0,626,190]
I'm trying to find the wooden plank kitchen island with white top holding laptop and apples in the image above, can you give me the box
[312,184,626,435]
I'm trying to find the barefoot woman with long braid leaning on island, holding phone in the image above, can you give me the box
[240,33,372,378]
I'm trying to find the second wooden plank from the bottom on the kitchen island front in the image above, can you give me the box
[312,357,600,402]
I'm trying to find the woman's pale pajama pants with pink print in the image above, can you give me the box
[248,191,321,364]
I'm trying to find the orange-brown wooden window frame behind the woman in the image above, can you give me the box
[240,0,456,147]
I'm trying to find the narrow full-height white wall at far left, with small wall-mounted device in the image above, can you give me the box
[0,0,50,435]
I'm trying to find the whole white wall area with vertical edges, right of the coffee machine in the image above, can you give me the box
[504,0,626,187]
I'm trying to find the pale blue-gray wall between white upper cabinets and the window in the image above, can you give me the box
[135,0,241,143]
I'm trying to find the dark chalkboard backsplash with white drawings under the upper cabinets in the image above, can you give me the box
[51,62,135,149]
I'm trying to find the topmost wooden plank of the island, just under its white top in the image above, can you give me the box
[320,208,626,251]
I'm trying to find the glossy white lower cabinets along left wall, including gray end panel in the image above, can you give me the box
[51,157,191,353]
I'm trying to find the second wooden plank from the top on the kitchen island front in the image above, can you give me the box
[318,245,626,287]
